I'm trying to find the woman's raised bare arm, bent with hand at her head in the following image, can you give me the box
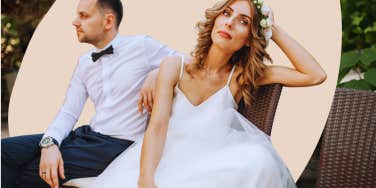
[257,10,326,87]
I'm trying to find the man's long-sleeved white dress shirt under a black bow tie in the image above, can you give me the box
[43,34,177,145]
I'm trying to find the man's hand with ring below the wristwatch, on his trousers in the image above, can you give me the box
[39,145,65,188]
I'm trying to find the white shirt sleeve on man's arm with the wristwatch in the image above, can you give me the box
[43,59,88,146]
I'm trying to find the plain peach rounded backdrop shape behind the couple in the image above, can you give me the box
[9,0,341,179]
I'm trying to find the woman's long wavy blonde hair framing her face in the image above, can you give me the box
[187,0,272,106]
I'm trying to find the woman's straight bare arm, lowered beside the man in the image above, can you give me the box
[139,57,180,187]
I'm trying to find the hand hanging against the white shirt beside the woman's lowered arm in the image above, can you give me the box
[138,69,159,113]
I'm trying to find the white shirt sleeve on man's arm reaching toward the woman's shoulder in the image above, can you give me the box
[144,35,181,70]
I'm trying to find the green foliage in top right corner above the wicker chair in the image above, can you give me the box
[338,0,376,90]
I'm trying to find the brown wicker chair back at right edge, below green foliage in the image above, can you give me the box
[317,88,376,188]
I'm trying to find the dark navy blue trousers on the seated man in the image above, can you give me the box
[1,125,133,188]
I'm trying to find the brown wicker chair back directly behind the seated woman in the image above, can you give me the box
[238,84,282,135]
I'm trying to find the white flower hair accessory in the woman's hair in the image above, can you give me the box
[253,0,273,45]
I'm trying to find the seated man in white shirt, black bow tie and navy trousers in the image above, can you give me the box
[1,0,176,188]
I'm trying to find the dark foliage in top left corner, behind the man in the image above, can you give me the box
[1,0,54,74]
